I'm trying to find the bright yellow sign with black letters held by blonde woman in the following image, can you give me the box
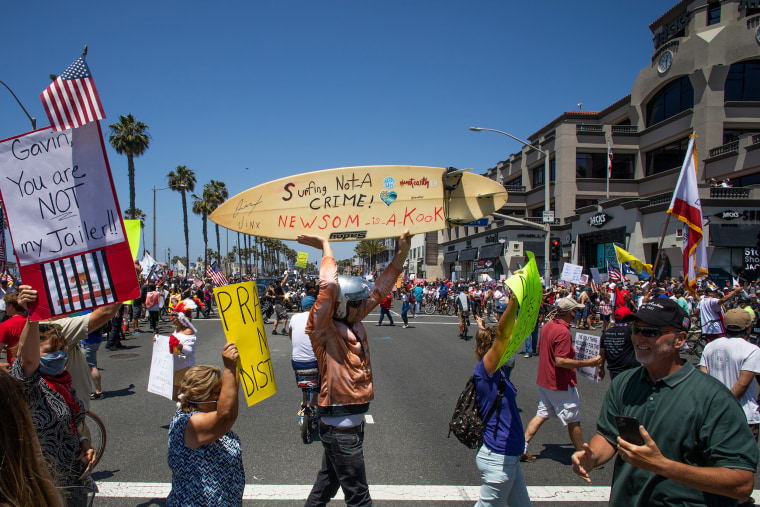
[214,281,277,407]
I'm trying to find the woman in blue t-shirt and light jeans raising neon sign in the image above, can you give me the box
[473,296,530,507]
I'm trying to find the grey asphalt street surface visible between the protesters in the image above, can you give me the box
[84,308,757,506]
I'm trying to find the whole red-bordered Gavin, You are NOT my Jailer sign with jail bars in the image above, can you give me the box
[0,122,140,320]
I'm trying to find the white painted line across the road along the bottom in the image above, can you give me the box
[98,481,620,504]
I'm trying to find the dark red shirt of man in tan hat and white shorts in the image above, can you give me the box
[536,319,578,391]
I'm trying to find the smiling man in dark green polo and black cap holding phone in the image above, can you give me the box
[572,299,758,507]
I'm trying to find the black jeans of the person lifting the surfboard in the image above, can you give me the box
[304,423,372,507]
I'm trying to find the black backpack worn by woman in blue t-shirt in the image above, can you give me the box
[448,369,507,449]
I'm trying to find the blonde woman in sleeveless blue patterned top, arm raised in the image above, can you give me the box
[166,343,245,507]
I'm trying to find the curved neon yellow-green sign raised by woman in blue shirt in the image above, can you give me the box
[499,252,544,366]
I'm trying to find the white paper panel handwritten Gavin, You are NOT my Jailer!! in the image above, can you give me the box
[0,122,126,266]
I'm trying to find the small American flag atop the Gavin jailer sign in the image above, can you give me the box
[40,56,106,131]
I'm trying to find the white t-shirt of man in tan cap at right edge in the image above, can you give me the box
[699,337,760,424]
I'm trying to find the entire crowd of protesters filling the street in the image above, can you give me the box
[0,244,760,506]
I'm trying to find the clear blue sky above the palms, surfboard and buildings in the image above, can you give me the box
[0,0,676,266]
